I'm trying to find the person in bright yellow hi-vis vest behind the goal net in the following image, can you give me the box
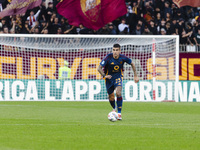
[59,60,71,80]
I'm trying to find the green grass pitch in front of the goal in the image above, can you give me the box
[0,101,200,150]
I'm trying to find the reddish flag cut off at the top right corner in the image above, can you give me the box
[173,0,200,7]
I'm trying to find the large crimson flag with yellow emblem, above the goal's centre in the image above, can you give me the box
[56,0,127,30]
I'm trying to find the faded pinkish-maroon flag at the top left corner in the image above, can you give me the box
[0,0,42,18]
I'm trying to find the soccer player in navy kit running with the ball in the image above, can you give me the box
[97,44,139,120]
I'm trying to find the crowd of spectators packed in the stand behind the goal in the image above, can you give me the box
[0,0,200,46]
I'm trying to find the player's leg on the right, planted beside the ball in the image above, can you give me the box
[115,86,123,120]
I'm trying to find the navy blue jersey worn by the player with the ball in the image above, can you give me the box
[100,53,132,80]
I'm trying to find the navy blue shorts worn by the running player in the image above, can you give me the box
[106,77,122,95]
